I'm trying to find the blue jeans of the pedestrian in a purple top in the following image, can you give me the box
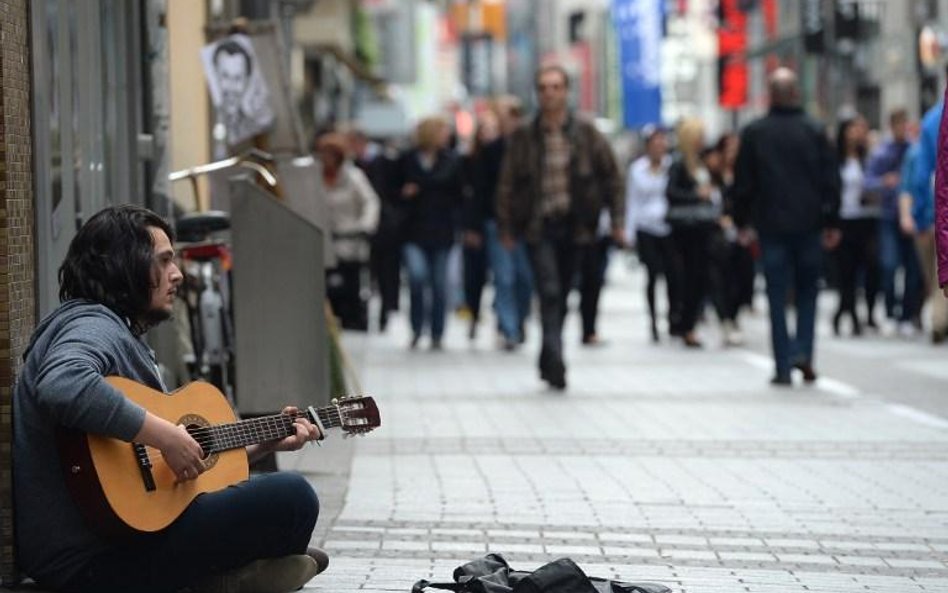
[879,220,922,321]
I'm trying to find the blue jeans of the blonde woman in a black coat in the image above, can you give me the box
[402,243,449,341]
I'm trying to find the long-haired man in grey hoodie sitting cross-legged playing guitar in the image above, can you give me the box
[13,206,328,593]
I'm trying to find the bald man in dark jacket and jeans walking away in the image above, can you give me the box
[734,68,840,385]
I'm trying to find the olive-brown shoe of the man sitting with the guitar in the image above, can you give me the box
[190,554,329,593]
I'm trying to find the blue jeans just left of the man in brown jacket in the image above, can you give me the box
[485,220,533,342]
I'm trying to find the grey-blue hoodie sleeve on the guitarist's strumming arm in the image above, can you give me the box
[34,315,145,441]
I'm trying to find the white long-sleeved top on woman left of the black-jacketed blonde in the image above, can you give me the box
[625,155,672,245]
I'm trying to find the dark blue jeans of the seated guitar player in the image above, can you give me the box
[65,473,319,593]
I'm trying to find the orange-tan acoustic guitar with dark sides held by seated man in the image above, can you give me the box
[57,377,381,538]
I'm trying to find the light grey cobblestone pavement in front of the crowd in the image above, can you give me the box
[281,265,948,593]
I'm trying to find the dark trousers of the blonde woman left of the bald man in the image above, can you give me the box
[672,225,713,334]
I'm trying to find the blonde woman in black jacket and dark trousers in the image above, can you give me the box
[665,118,721,348]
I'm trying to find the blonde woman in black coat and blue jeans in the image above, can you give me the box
[400,117,461,350]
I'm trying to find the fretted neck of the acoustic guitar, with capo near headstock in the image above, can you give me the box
[191,406,342,455]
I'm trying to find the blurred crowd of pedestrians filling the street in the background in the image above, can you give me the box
[314,65,948,389]
